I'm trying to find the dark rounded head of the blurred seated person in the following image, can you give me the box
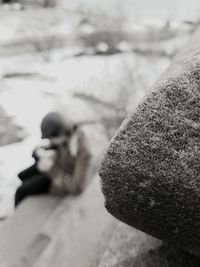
[40,112,77,144]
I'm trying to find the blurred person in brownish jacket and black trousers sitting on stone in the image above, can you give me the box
[15,112,91,207]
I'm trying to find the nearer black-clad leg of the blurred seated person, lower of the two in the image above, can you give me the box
[15,174,51,207]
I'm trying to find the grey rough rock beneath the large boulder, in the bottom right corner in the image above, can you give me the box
[98,222,200,267]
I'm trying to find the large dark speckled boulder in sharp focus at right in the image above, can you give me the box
[99,27,200,256]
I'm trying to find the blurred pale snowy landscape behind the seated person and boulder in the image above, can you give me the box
[0,0,200,218]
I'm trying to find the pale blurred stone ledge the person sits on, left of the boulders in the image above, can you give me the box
[0,177,116,267]
